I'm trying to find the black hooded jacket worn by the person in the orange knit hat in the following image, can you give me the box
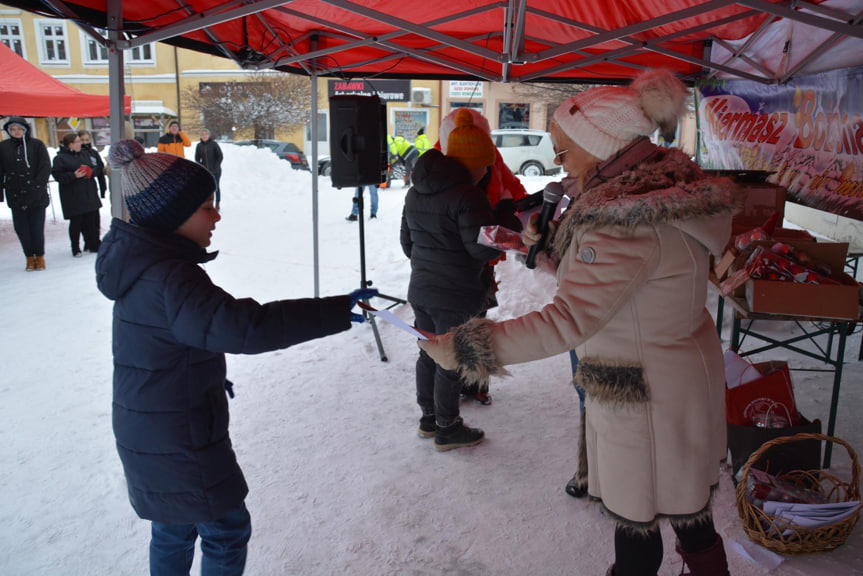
[401,150,501,314]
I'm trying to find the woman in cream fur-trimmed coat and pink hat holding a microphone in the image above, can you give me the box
[420,71,736,576]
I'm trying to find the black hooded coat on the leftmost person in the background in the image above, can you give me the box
[0,116,51,210]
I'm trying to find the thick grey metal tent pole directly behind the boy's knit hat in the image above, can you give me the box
[108,0,131,221]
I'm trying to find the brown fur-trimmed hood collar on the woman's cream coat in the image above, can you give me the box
[551,148,740,258]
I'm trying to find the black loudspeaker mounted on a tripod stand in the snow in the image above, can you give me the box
[330,96,387,188]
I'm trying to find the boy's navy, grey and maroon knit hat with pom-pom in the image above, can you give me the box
[108,140,216,232]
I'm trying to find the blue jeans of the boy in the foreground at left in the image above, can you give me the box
[150,504,252,576]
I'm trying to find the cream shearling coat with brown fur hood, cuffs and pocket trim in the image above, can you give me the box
[454,149,735,527]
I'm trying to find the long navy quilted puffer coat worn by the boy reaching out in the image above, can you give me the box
[96,219,351,524]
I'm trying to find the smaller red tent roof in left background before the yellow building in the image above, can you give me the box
[0,42,132,118]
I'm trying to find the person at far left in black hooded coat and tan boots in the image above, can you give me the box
[0,116,51,272]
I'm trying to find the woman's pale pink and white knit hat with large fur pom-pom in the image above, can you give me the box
[553,70,689,160]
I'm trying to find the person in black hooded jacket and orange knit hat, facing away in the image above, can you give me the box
[400,110,500,451]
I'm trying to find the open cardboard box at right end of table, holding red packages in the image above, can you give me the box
[746,242,860,320]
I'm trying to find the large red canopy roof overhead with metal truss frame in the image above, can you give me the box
[4,0,863,84]
